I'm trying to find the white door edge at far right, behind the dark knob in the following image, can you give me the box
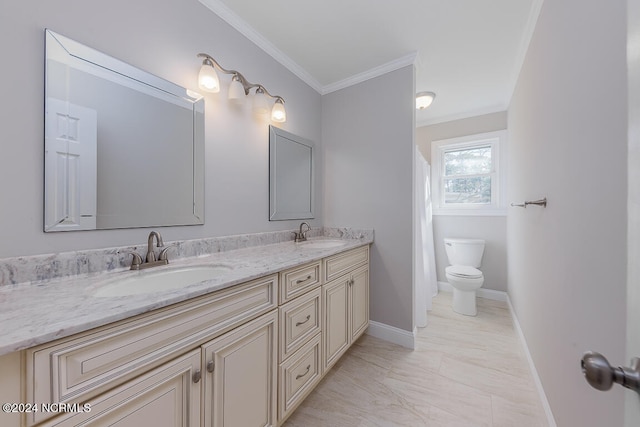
[625,0,640,427]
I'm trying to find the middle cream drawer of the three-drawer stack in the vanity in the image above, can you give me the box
[279,287,322,362]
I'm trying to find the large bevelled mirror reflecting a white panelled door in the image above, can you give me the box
[44,30,204,232]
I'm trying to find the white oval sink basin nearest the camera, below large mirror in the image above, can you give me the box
[94,265,231,297]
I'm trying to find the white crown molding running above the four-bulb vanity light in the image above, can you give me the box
[199,0,323,93]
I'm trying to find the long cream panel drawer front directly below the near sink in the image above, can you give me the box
[26,275,278,421]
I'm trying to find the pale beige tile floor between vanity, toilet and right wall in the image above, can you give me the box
[284,292,548,427]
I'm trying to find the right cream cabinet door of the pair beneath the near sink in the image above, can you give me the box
[202,310,278,427]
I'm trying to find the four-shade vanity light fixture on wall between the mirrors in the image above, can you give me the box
[198,53,287,123]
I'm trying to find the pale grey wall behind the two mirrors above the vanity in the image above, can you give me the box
[0,0,320,258]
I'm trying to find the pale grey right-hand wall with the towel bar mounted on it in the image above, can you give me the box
[507,0,637,427]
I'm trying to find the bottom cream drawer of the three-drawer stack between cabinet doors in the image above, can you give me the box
[278,334,322,423]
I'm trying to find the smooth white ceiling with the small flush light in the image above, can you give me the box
[200,0,543,126]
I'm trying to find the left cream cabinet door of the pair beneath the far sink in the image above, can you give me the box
[322,276,351,371]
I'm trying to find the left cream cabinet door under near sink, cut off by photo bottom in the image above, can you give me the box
[38,349,202,427]
